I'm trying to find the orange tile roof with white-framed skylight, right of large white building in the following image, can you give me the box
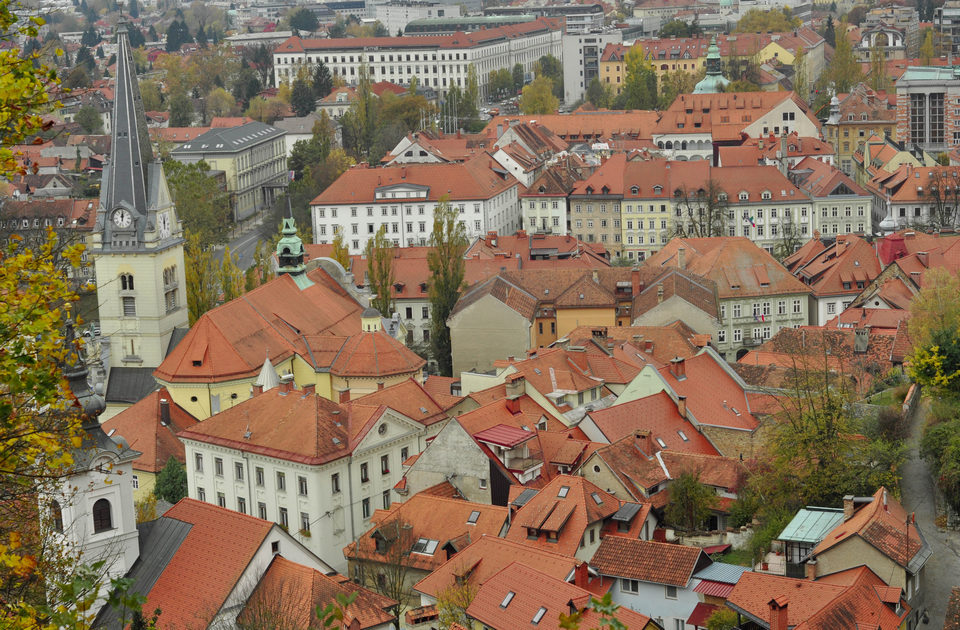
[343,492,507,571]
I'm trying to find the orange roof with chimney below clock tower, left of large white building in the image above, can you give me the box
[103,388,197,473]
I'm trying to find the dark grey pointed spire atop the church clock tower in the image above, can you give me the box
[100,22,153,220]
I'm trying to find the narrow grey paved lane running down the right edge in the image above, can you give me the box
[901,402,960,628]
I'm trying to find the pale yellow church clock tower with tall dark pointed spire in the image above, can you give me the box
[92,23,188,376]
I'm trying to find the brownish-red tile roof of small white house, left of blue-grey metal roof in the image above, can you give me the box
[590,535,711,588]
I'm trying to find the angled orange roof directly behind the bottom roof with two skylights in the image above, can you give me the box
[413,536,580,597]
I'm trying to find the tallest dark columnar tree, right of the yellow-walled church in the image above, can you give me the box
[427,196,469,376]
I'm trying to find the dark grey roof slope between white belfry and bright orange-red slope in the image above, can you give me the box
[93,516,193,630]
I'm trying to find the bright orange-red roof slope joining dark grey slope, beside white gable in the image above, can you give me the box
[144,499,275,628]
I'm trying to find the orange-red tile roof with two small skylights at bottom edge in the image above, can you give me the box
[467,563,650,630]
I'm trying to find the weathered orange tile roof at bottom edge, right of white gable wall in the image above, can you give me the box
[237,555,397,630]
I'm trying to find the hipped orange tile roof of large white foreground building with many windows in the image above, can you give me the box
[179,388,387,465]
